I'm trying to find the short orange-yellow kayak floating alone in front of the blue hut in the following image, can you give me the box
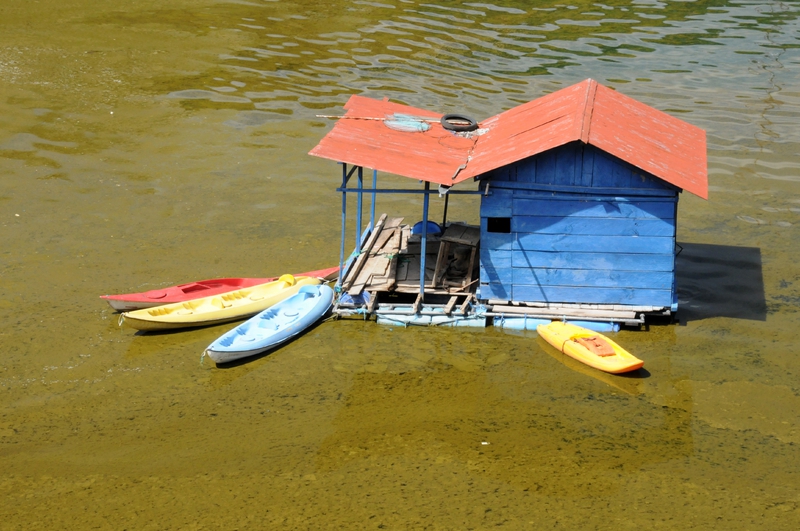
[536,321,644,374]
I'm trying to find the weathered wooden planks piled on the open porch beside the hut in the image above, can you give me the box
[338,214,480,313]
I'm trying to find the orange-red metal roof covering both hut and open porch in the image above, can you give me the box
[311,79,708,199]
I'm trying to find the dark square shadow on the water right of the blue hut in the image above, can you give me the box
[675,243,767,324]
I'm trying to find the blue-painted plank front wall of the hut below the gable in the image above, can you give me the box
[480,145,678,307]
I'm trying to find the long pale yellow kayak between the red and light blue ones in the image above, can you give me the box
[121,275,322,331]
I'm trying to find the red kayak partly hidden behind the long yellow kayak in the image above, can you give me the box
[100,266,339,312]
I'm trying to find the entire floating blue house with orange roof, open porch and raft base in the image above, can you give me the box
[311,79,708,324]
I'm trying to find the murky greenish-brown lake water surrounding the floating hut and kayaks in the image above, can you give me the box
[0,0,800,530]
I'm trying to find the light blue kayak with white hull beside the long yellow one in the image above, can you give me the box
[205,284,333,363]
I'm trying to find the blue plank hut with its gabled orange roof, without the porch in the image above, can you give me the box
[479,80,707,321]
